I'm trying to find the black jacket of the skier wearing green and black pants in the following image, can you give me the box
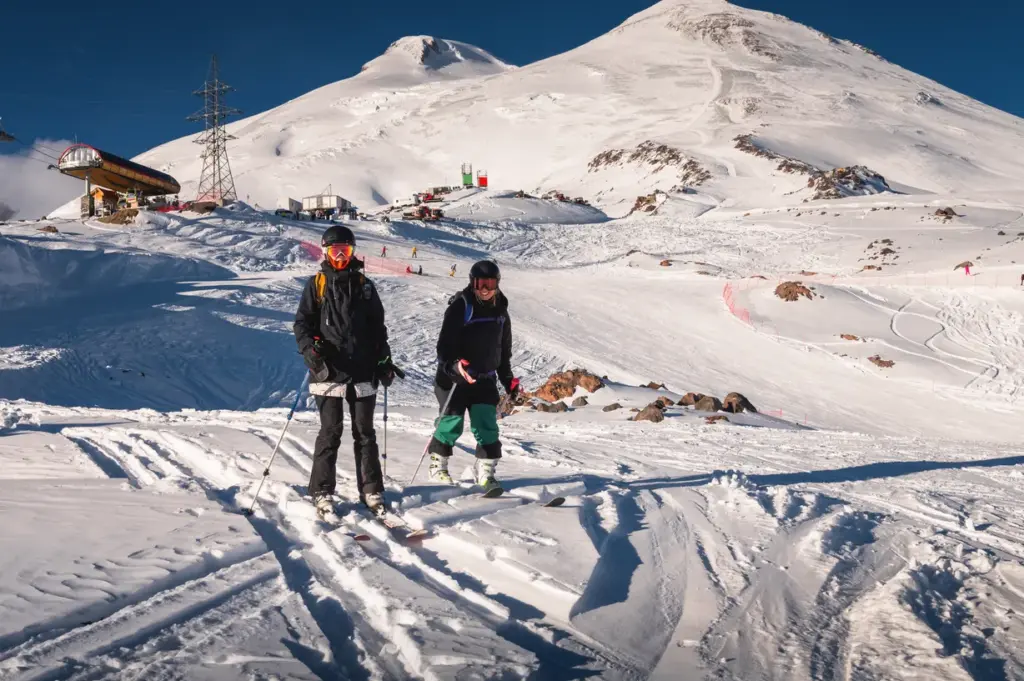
[435,287,512,390]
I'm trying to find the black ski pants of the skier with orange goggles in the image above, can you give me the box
[309,385,384,498]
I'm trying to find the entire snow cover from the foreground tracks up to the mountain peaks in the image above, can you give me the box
[6,0,1024,681]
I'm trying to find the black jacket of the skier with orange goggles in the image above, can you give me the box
[294,258,391,383]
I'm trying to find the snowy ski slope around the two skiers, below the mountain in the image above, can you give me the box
[6,180,1024,681]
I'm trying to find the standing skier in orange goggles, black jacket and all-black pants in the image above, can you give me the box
[295,225,394,513]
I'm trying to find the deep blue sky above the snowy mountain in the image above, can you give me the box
[0,0,1024,160]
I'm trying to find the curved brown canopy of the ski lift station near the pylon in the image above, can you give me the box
[57,144,181,197]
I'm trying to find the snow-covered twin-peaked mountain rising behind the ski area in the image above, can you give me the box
[128,0,1024,215]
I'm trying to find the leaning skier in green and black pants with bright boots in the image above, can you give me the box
[428,260,519,491]
